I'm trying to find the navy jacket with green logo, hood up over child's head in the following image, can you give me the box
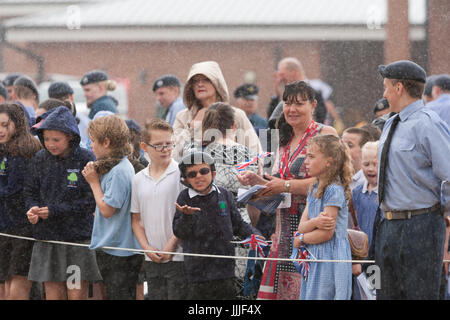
[24,106,95,241]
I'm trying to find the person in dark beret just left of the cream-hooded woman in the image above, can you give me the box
[153,74,186,126]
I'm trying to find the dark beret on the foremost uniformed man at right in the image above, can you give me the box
[378,60,427,83]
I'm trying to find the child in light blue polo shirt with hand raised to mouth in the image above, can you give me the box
[82,115,143,300]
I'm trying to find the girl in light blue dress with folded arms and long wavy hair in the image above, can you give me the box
[294,135,352,300]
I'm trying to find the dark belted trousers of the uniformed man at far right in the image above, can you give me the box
[375,212,445,300]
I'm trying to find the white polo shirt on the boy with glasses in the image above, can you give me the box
[131,159,186,261]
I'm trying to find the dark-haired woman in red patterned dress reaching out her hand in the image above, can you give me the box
[238,81,337,300]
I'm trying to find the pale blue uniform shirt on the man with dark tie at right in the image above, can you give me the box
[378,100,450,212]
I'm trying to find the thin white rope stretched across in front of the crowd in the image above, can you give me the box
[0,233,450,264]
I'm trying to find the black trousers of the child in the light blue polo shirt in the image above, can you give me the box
[96,250,144,300]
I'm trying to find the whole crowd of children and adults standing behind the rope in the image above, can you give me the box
[0,57,450,300]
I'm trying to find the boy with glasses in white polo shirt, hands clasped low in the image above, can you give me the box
[131,119,186,300]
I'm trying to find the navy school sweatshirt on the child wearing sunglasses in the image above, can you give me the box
[173,186,261,282]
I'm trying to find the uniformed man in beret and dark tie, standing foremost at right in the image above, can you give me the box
[374,60,450,300]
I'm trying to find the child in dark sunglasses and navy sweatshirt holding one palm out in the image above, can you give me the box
[173,151,264,300]
